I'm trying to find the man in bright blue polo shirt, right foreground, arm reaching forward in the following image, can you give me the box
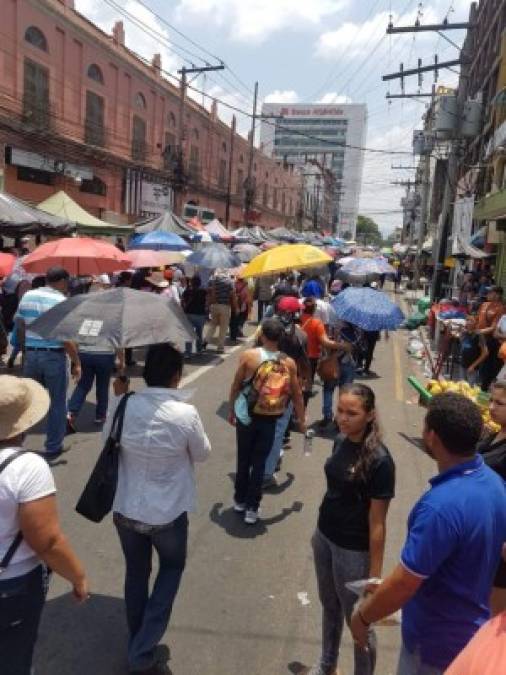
[351,393,506,675]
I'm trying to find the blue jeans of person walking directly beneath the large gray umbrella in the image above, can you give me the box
[68,352,115,419]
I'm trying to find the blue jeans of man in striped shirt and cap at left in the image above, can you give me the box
[23,349,68,454]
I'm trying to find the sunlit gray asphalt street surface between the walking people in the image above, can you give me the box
[27,312,432,675]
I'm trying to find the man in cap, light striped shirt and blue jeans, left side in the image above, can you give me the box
[16,267,81,460]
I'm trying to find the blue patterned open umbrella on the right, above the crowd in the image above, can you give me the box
[331,288,404,330]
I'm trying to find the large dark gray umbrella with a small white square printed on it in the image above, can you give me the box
[30,288,195,348]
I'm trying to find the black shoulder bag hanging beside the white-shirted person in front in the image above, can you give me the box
[76,392,133,523]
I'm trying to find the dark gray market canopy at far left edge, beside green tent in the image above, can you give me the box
[0,192,75,237]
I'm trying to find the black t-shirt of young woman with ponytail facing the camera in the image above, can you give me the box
[318,435,395,551]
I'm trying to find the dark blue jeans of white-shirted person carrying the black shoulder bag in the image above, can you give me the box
[114,512,188,670]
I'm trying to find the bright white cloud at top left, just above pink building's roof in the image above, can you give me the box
[75,0,182,72]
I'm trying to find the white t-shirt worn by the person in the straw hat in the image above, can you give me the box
[0,448,56,580]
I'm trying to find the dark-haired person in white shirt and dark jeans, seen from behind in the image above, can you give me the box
[108,344,211,675]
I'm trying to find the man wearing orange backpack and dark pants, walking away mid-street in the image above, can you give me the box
[228,319,305,525]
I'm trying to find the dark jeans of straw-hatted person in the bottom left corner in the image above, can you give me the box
[0,565,47,675]
